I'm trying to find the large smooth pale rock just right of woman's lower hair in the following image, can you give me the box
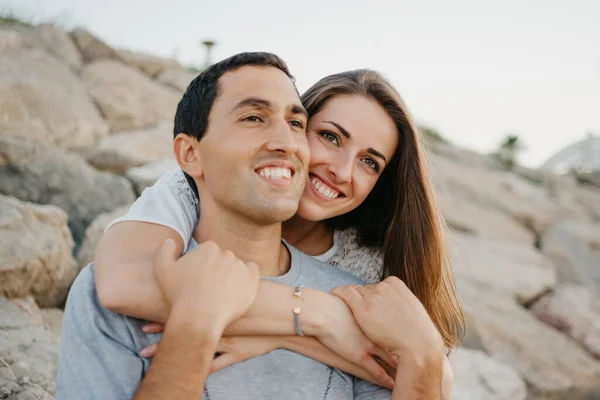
[450,233,556,303]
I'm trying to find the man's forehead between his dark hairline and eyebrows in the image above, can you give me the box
[219,66,300,106]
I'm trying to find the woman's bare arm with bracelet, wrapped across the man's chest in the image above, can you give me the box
[95,222,393,379]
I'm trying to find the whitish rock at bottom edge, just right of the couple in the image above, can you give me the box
[450,347,527,400]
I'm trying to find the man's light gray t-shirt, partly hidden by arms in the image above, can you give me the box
[56,245,391,400]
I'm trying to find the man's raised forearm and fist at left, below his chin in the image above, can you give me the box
[134,240,260,400]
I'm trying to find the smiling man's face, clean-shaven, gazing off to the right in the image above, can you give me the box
[198,66,310,224]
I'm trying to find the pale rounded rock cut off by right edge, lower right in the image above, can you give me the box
[531,284,600,359]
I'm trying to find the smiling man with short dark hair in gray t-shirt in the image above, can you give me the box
[56,53,439,400]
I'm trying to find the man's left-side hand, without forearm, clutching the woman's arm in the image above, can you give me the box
[154,240,260,336]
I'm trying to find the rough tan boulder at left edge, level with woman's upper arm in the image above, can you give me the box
[0,195,79,307]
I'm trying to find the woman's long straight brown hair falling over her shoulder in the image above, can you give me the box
[302,69,465,350]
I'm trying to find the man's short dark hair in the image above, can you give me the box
[173,52,294,140]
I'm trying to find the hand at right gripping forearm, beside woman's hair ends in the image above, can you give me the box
[331,277,444,357]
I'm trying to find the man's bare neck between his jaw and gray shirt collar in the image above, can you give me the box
[193,205,291,276]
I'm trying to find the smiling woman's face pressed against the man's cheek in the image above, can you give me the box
[298,95,398,221]
